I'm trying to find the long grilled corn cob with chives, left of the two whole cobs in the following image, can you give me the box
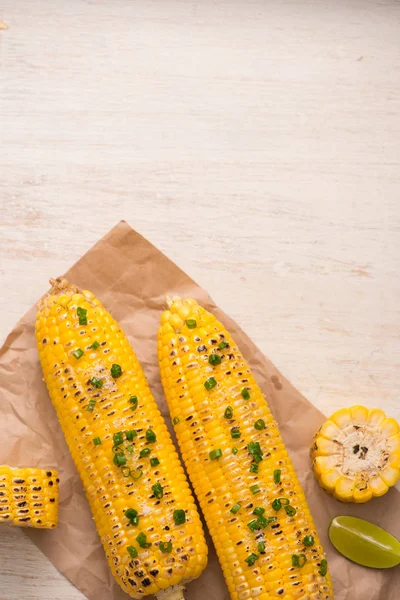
[36,280,207,600]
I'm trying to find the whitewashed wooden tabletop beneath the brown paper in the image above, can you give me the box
[0,0,400,600]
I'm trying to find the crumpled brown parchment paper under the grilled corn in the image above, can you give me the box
[0,222,400,600]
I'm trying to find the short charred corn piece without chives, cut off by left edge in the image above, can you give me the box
[0,465,59,529]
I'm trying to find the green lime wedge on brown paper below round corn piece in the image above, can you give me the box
[329,517,400,569]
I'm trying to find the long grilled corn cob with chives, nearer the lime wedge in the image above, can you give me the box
[158,299,333,600]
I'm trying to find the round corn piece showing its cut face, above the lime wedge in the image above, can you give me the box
[311,406,400,503]
